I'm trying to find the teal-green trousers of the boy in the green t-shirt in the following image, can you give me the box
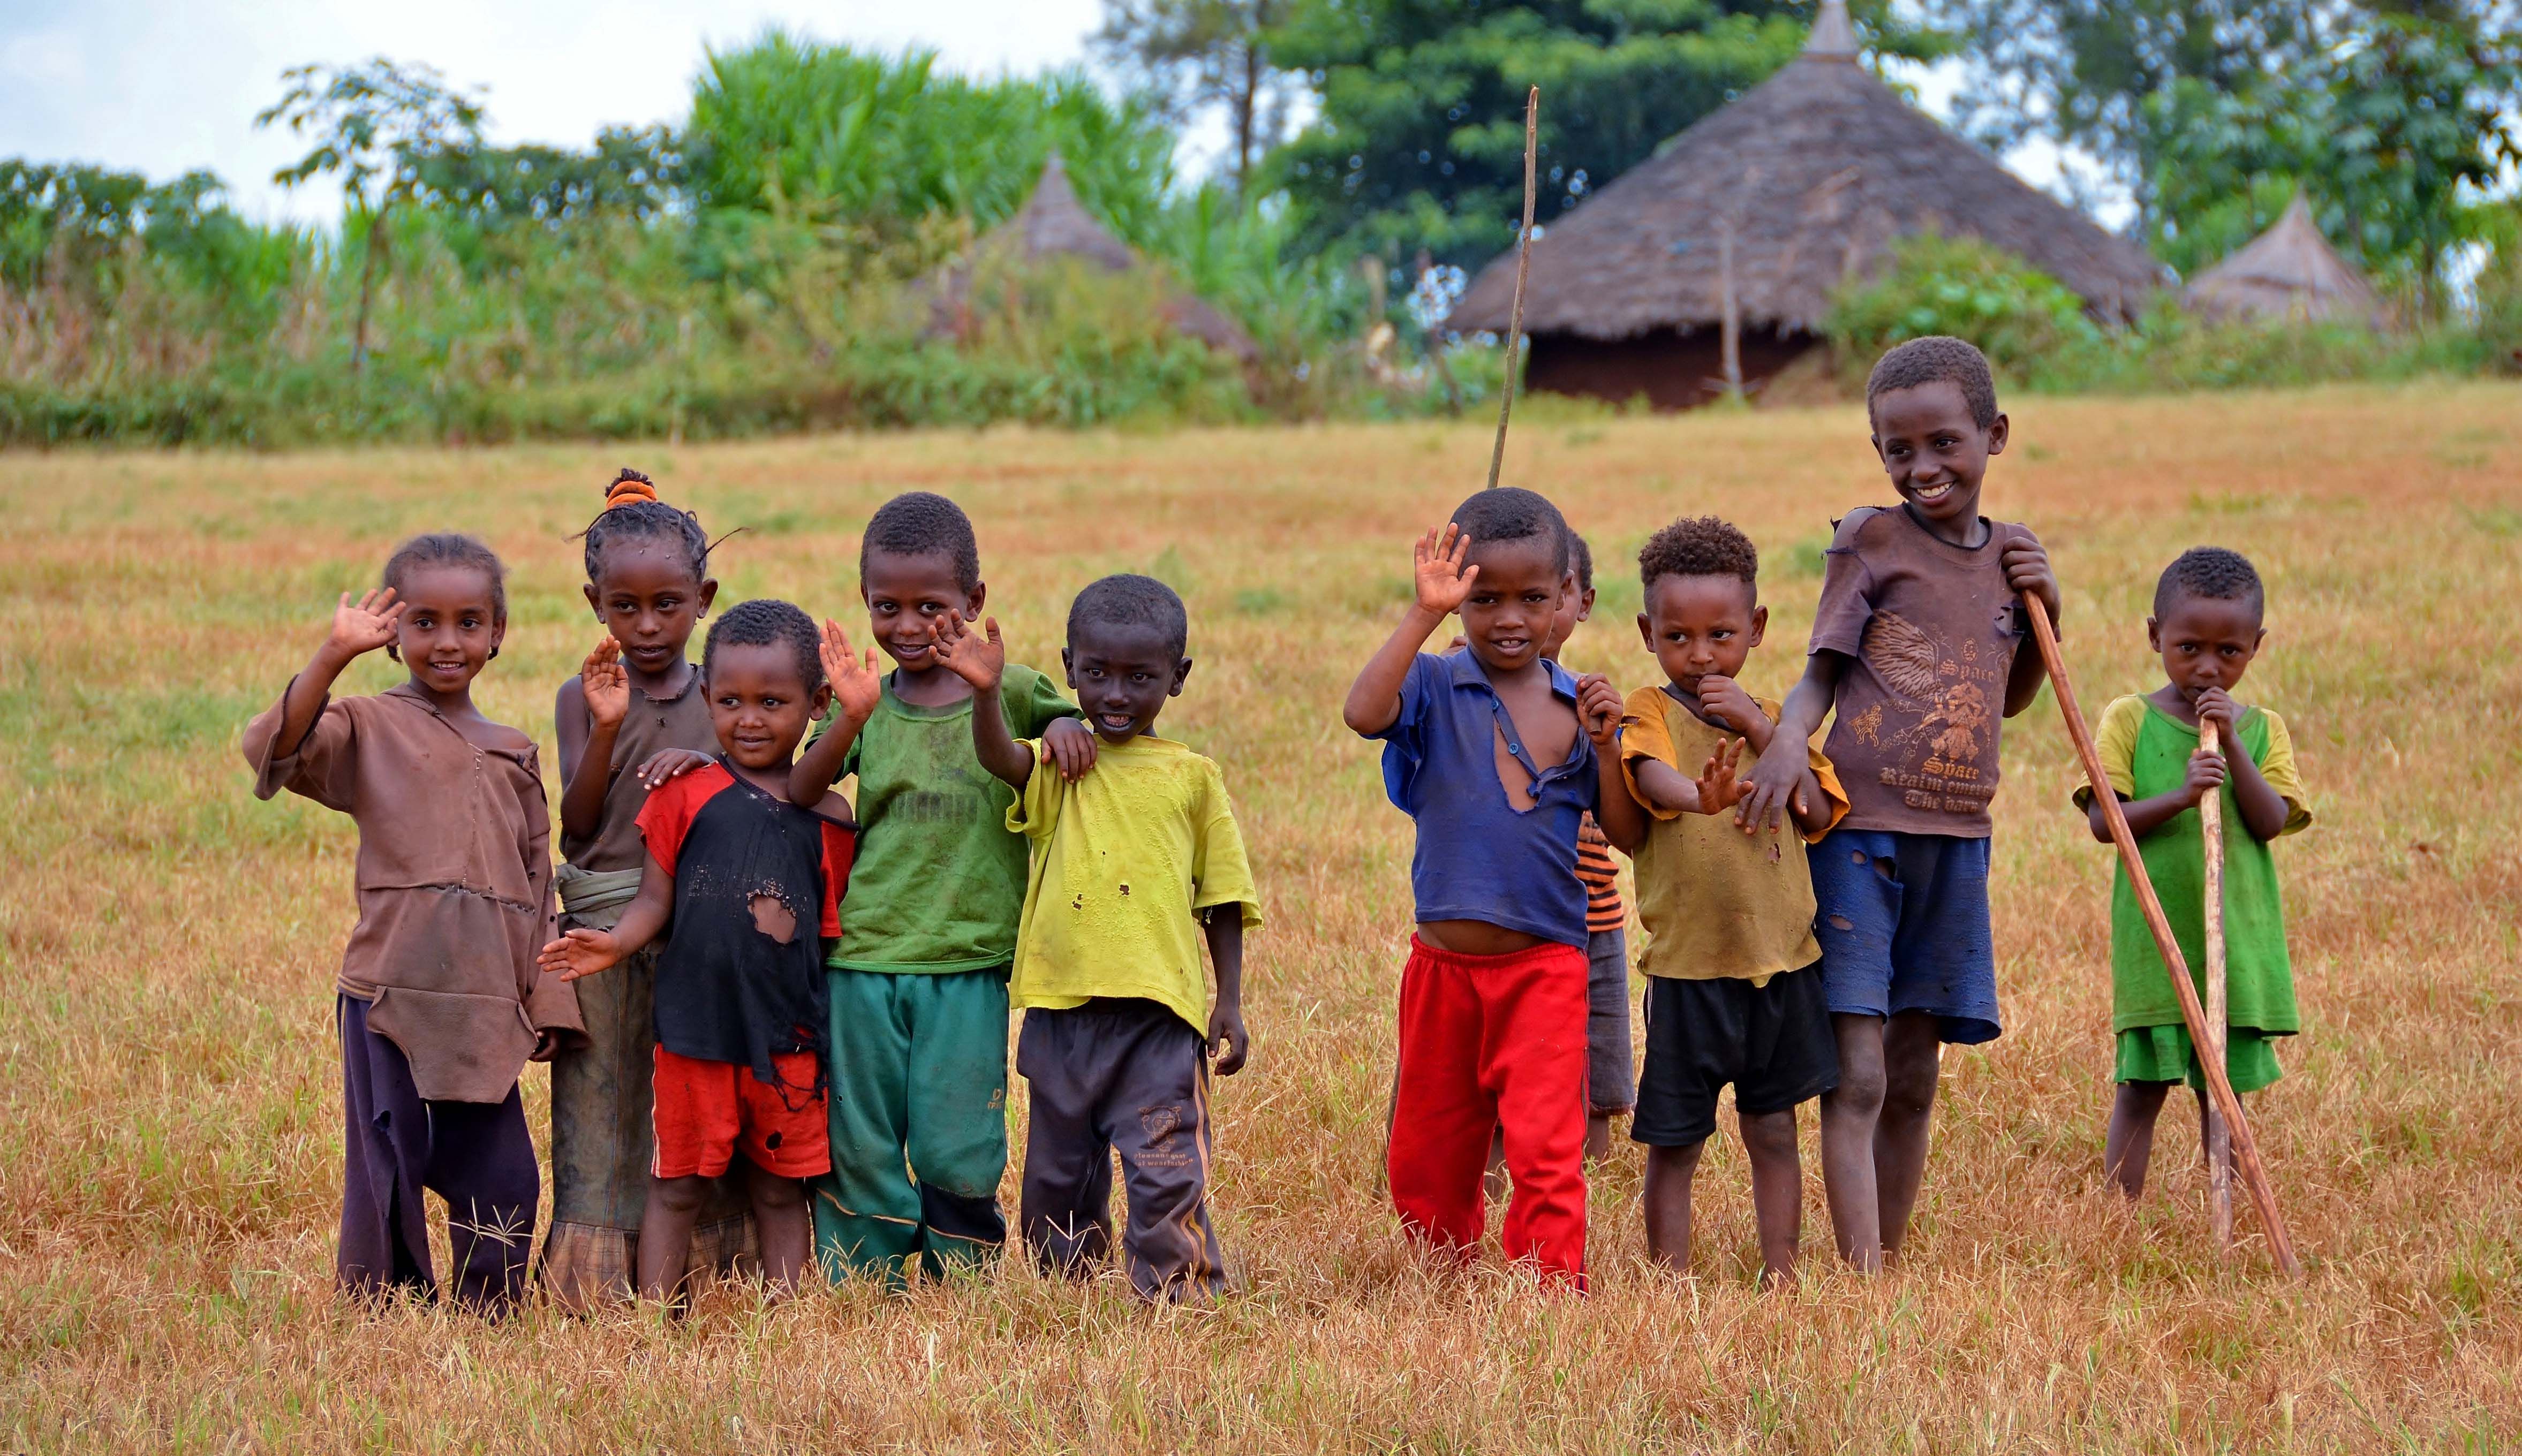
[812,966,1006,1279]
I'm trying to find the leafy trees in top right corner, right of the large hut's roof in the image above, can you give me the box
[1929,0,2522,263]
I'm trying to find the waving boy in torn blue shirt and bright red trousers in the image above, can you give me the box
[1342,487,1619,1290]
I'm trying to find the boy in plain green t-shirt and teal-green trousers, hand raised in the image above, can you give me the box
[789,490,1094,1279]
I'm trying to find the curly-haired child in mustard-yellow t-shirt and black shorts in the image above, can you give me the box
[1602,515,1848,1282]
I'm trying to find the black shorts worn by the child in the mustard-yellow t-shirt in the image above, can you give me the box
[1629,964,1839,1148]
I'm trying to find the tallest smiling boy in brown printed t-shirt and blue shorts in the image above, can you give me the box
[1738,336,2058,1269]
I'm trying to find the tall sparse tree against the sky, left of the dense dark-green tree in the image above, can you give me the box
[1094,0,1294,197]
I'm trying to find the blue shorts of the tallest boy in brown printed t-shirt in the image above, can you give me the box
[1811,830,2003,1042]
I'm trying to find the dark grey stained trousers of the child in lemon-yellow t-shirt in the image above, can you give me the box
[1016,997,1226,1300]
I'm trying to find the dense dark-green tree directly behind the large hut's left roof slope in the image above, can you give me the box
[1268,0,1942,268]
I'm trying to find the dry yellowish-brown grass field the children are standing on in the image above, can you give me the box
[0,384,2522,1451]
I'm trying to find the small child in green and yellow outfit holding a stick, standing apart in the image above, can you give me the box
[2075,545,2313,1199]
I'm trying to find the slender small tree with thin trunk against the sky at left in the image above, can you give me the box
[255,56,484,374]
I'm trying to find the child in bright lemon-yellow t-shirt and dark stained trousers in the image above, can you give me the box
[935,575,1261,1300]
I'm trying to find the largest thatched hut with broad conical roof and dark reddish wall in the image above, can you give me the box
[1448,0,2161,409]
